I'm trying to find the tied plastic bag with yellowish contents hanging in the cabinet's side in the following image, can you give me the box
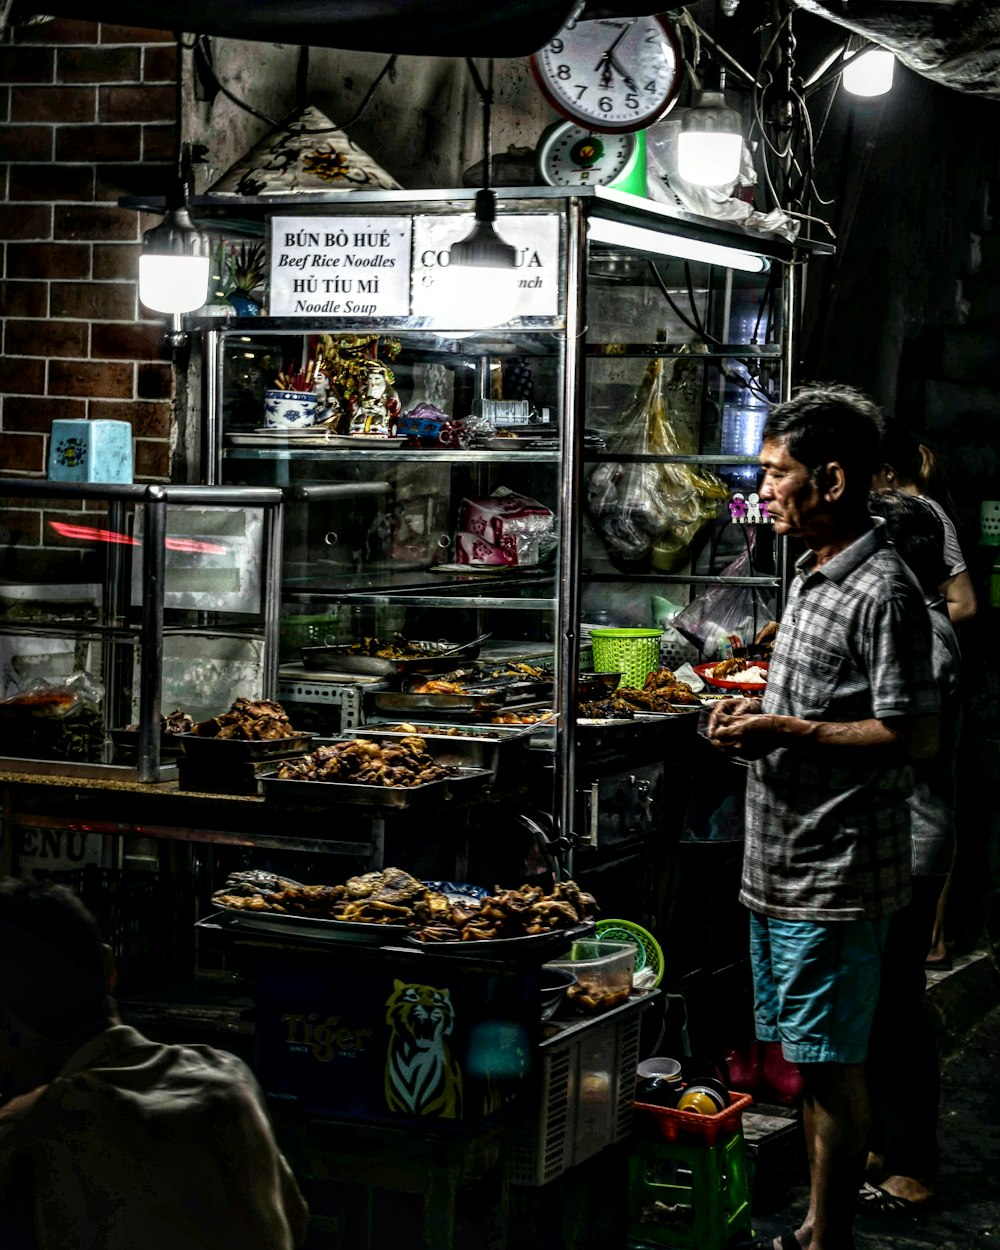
[588,360,729,570]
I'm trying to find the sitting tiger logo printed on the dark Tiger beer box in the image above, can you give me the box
[385,981,463,1120]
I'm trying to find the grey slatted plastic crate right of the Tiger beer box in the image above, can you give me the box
[509,990,659,1185]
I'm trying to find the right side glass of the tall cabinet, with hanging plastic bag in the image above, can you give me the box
[581,238,784,663]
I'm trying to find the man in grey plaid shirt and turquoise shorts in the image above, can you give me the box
[709,385,939,1250]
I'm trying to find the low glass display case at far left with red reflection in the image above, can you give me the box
[0,479,283,783]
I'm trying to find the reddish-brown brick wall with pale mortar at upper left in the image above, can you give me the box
[0,20,178,481]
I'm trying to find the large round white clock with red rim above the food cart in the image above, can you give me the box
[531,16,681,134]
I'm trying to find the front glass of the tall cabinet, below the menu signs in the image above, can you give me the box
[214,326,565,760]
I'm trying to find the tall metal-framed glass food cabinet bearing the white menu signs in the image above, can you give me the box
[199,188,820,841]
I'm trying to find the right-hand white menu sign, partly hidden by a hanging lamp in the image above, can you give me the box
[413,213,560,318]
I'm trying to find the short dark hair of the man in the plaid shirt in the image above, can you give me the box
[764,383,883,499]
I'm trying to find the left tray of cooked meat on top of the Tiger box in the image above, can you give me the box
[213,868,467,946]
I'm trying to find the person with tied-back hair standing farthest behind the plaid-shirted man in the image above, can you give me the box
[871,421,976,625]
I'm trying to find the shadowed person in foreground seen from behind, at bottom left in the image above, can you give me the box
[0,880,309,1250]
